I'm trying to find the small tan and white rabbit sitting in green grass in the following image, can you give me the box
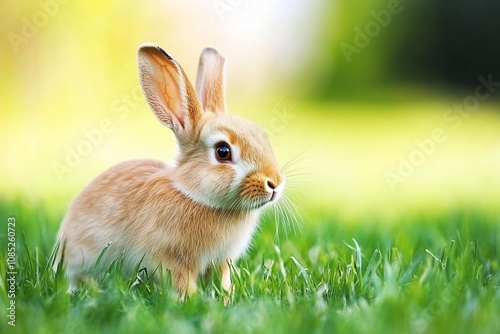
[54,44,286,298]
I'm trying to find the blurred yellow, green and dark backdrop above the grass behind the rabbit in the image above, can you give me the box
[0,0,500,222]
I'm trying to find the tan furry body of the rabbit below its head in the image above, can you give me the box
[59,160,258,292]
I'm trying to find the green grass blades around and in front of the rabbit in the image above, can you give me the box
[0,200,500,334]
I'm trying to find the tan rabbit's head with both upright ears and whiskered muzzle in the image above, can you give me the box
[138,44,285,211]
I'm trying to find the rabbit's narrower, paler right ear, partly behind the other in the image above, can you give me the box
[196,48,226,113]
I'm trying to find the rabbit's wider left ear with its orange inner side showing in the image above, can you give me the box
[137,44,202,139]
